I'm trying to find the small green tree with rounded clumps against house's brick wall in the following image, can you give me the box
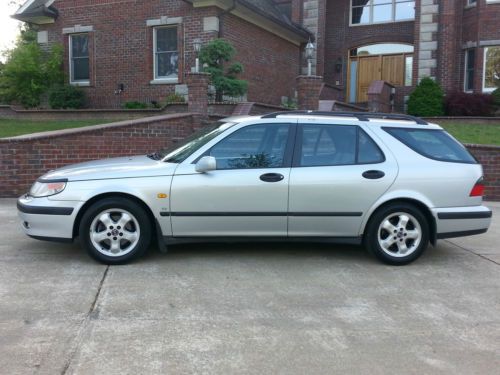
[200,39,248,101]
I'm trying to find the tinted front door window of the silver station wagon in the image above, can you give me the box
[209,124,289,169]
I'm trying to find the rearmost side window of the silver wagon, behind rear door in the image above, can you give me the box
[383,128,476,164]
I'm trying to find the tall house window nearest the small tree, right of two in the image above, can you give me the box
[153,27,179,80]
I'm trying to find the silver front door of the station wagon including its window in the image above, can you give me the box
[170,123,293,237]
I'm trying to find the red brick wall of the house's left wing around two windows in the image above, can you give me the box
[42,0,299,108]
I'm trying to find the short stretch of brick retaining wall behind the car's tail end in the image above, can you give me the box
[467,145,500,201]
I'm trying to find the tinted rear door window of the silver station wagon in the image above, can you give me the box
[294,124,385,167]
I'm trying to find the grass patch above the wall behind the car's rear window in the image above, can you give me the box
[439,122,500,146]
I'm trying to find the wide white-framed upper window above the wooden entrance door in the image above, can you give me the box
[351,0,415,25]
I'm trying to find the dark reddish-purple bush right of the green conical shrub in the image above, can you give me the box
[445,91,493,116]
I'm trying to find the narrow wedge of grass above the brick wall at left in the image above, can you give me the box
[0,119,117,138]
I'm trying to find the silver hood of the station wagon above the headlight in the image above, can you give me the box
[40,156,177,181]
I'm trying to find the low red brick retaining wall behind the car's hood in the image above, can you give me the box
[0,114,198,197]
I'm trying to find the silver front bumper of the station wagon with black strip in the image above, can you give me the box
[17,195,84,241]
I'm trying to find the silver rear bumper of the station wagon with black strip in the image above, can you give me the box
[432,206,492,239]
